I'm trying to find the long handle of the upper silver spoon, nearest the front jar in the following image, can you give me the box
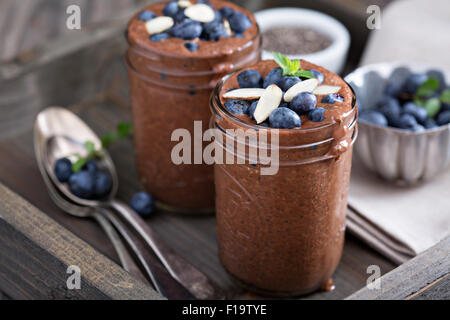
[110,200,224,299]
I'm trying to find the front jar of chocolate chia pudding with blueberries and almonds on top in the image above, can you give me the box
[210,60,357,296]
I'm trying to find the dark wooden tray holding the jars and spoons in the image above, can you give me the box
[0,8,448,299]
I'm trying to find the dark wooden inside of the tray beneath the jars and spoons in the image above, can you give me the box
[0,14,394,299]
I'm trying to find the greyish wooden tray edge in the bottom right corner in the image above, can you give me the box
[348,237,450,300]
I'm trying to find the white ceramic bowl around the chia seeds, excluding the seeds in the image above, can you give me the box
[255,8,350,73]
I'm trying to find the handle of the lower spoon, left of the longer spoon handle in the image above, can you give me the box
[92,210,146,281]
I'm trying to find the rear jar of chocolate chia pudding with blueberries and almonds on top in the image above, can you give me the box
[126,0,261,212]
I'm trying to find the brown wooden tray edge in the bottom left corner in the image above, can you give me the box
[0,185,160,300]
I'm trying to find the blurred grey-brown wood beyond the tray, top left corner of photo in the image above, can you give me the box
[0,0,156,61]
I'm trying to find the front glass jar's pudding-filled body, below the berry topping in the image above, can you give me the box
[210,77,357,296]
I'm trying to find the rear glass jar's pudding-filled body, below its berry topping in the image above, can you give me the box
[126,9,261,212]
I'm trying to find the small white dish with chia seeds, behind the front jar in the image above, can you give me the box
[255,8,350,73]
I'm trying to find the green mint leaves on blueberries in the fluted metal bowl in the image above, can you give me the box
[413,77,450,118]
